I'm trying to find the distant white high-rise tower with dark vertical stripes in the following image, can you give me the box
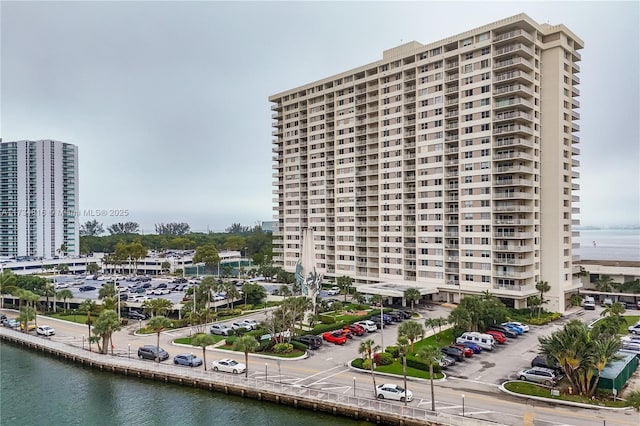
[0,140,80,258]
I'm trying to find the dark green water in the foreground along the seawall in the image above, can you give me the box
[0,343,368,426]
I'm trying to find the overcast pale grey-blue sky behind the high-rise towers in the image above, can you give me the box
[0,1,640,232]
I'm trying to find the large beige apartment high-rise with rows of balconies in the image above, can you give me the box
[269,14,583,312]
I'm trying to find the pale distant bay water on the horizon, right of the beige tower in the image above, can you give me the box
[578,229,640,261]
